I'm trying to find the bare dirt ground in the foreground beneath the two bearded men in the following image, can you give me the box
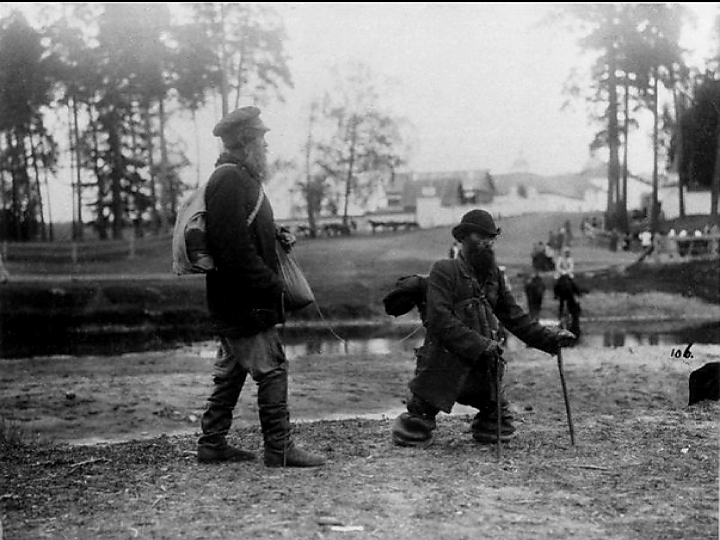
[0,336,720,540]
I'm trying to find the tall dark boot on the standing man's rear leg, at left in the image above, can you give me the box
[197,373,255,463]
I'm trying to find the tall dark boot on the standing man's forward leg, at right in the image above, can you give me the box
[257,365,325,467]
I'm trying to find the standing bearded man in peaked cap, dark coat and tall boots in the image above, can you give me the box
[197,107,325,467]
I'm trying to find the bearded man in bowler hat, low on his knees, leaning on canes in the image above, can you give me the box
[392,209,575,446]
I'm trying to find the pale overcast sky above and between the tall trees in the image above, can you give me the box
[8,2,718,219]
